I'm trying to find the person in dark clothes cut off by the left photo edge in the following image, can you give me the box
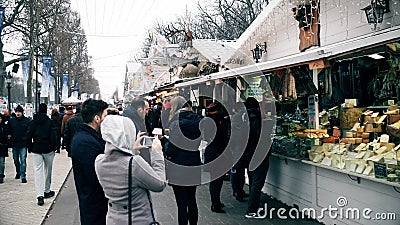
[0,114,10,184]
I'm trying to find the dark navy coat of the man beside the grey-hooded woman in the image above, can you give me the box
[71,124,108,225]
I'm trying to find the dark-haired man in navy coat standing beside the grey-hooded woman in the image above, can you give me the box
[71,99,108,225]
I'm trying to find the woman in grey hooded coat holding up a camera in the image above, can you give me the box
[95,115,166,225]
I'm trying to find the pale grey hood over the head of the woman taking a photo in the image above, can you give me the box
[100,115,136,154]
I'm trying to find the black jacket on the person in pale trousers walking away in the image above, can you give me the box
[26,113,57,154]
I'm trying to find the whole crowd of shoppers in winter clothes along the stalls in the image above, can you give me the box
[0,96,270,225]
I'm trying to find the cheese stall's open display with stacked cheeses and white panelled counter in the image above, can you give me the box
[263,39,400,225]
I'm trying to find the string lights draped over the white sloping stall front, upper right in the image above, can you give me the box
[228,0,400,66]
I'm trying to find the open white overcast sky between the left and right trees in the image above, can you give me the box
[71,0,197,98]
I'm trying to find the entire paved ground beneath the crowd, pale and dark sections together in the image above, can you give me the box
[0,147,319,225]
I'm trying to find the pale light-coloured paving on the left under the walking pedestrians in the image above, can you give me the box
[0,149,71,225]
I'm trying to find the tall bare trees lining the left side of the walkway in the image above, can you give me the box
[0,0,100,102]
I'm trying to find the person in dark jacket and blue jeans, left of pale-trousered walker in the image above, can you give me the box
[8,105,30,183]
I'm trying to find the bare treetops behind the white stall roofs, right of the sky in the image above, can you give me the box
[155,0,269,43]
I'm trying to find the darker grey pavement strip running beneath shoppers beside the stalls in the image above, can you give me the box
[43,167,319,225]
